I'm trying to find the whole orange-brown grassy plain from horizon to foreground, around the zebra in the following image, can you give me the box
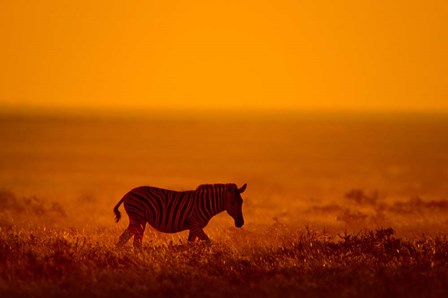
[0,115,448,297]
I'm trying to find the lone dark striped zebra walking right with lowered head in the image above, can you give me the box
[114,183,247,249]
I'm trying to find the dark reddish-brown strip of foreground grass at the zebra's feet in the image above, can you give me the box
[0,224,448,297]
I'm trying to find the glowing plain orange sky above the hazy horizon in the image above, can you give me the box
[0,0,448,111]
